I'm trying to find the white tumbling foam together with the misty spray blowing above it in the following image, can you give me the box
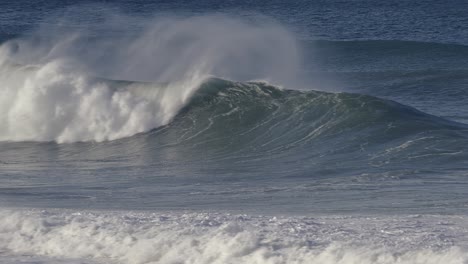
[0,15,298,143]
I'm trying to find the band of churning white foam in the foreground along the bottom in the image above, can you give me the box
[0,210,468,264]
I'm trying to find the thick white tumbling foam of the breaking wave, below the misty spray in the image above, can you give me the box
[0,60,198,143]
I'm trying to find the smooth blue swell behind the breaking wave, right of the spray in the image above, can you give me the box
[304,40,468,123]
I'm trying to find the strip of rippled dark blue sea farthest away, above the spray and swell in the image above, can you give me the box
[1,0,468,44]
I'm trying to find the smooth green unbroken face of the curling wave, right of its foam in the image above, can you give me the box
[169,79,466,152]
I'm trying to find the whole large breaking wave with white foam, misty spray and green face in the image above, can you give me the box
[0,12,466,167]
